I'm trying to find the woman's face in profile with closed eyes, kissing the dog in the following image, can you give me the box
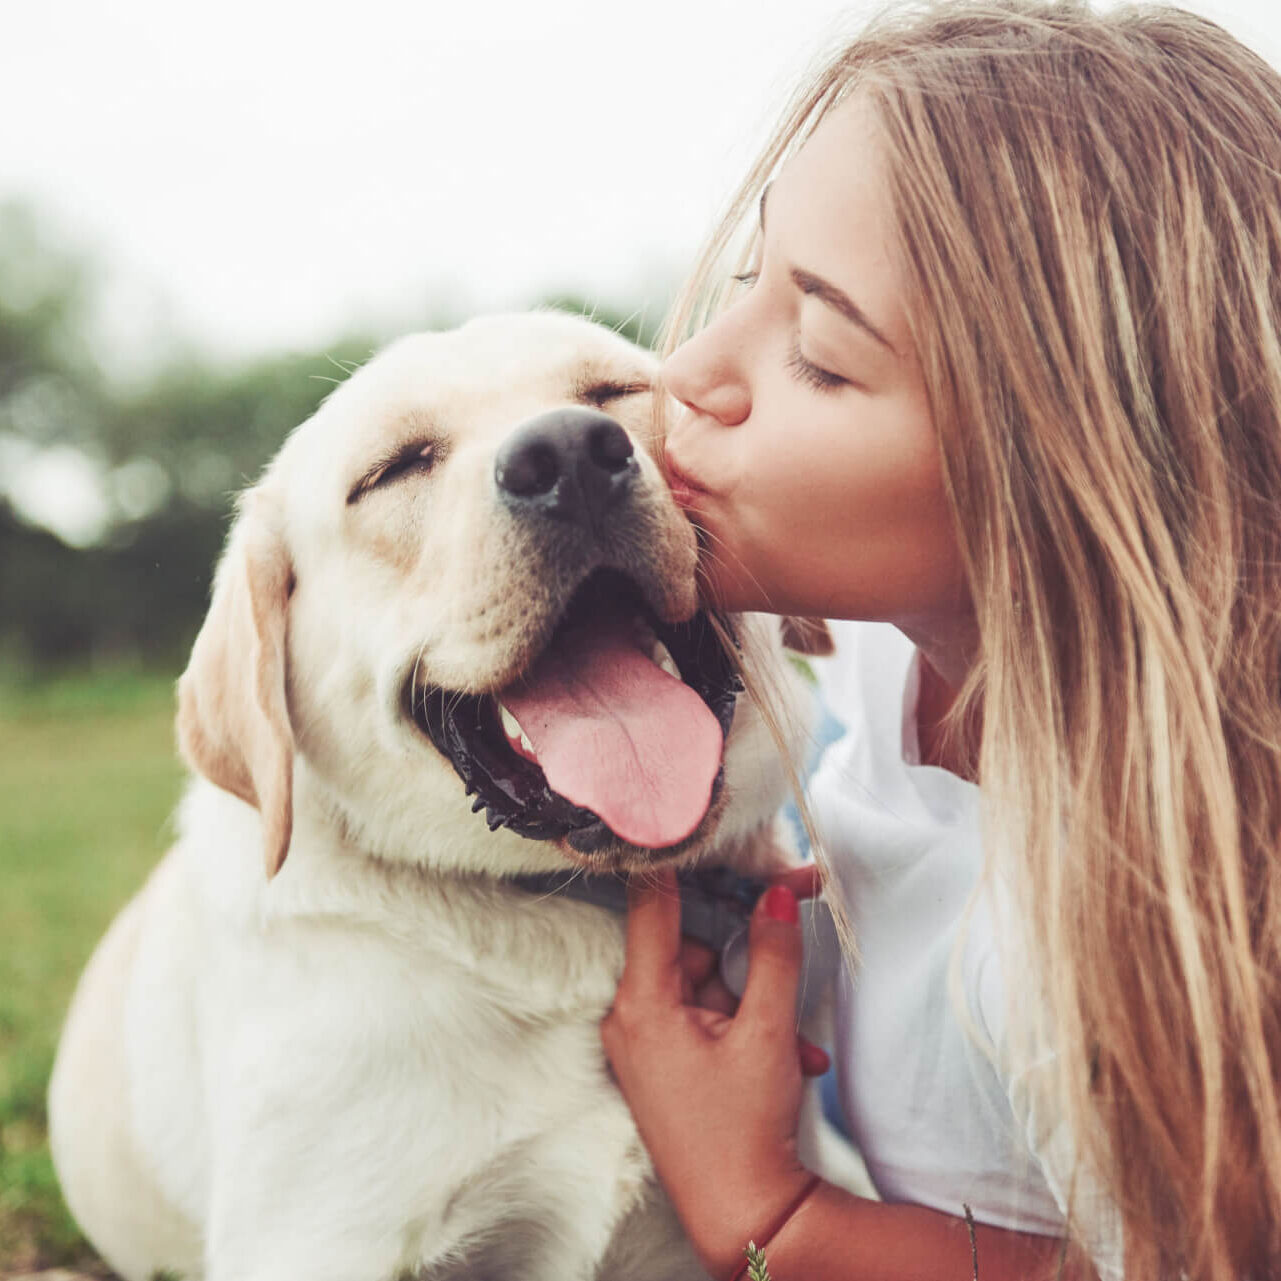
[664,99,967,632]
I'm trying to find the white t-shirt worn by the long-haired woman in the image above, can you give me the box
[810,623,1122,1281]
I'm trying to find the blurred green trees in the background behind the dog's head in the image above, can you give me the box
[0,204,657,670]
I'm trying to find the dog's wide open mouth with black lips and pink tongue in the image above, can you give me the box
[406,570,742,853]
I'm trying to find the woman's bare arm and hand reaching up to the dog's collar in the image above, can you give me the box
[601,871,1084,1281]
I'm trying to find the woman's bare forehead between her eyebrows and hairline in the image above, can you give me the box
[765,95,910,351]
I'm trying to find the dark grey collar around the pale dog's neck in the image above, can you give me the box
[512,867,766,952]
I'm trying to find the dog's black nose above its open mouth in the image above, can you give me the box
[493,409,641,529]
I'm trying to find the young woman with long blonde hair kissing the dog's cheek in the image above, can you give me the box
[602,0,1281,1281]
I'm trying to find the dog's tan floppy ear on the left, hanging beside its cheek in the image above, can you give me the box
[178,491,293,876]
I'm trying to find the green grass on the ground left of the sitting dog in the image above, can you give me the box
[0,673,182,1276]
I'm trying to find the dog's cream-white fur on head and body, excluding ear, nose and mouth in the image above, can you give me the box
[50,315,814,1281]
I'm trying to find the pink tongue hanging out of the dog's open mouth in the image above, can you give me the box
[500,621,722,849]
